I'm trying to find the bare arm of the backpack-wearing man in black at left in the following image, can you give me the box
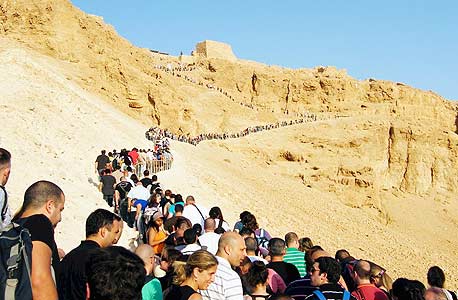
[31,241,58,300]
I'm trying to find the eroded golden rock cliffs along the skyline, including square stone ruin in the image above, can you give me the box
[0,0,458,204]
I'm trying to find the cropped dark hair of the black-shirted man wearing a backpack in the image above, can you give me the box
[13,180,64,221]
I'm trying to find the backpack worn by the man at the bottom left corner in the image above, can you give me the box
[0,223,32,300]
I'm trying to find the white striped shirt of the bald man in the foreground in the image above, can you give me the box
[200,256,243,300]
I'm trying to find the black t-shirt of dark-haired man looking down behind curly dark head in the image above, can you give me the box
[57,241,100,300]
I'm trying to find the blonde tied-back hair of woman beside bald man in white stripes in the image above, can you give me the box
[173,250,218,285]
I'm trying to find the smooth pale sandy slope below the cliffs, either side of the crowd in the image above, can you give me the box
[0,39,458,286]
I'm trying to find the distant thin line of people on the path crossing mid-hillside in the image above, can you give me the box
[145,113,322,146]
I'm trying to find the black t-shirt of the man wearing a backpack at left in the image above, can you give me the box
[20,214,60,279]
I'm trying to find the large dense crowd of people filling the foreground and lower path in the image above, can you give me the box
[0,148,457,300]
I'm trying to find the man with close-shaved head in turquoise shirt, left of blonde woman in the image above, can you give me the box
[135,244,162,300]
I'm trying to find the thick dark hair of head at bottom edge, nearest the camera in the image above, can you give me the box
[86,246,146,300]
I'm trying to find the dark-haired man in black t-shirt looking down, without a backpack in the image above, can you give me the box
[57,208,122,300]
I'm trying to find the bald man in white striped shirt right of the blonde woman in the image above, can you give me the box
[201,232,246,300]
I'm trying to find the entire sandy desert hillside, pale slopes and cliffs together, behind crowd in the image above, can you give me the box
[0,0,458,286]
